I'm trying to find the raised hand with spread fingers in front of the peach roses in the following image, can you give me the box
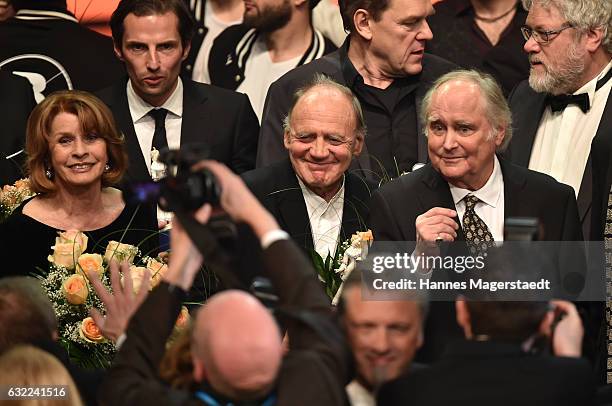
[89,261,151,341]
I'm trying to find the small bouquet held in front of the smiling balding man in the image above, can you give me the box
[312,230,374,305]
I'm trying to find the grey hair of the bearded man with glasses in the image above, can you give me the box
[522,0,612,54]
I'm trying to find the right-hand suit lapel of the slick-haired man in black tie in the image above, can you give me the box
[181,79,213,146]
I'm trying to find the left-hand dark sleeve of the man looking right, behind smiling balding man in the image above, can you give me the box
[257,81,293,168]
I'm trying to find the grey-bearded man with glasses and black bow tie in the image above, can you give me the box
[509,0,612,240]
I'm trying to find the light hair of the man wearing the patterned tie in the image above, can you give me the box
[421,70,512,152]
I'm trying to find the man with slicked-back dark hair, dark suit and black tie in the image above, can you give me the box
[98,0,259,181]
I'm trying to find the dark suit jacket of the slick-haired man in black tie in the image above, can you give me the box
[97,78,259,181]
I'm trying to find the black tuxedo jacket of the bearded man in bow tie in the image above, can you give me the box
[509,81,612,240]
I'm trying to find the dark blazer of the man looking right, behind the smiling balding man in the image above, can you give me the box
[257,40,457,176]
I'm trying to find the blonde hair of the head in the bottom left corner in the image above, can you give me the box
[0,345,83,406]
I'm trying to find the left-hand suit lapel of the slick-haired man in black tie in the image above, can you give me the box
[109,82,151,182]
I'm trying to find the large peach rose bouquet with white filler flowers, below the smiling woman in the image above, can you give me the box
[39,231,167,368]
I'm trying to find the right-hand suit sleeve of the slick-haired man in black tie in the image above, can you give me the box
[231,94,259,174]
